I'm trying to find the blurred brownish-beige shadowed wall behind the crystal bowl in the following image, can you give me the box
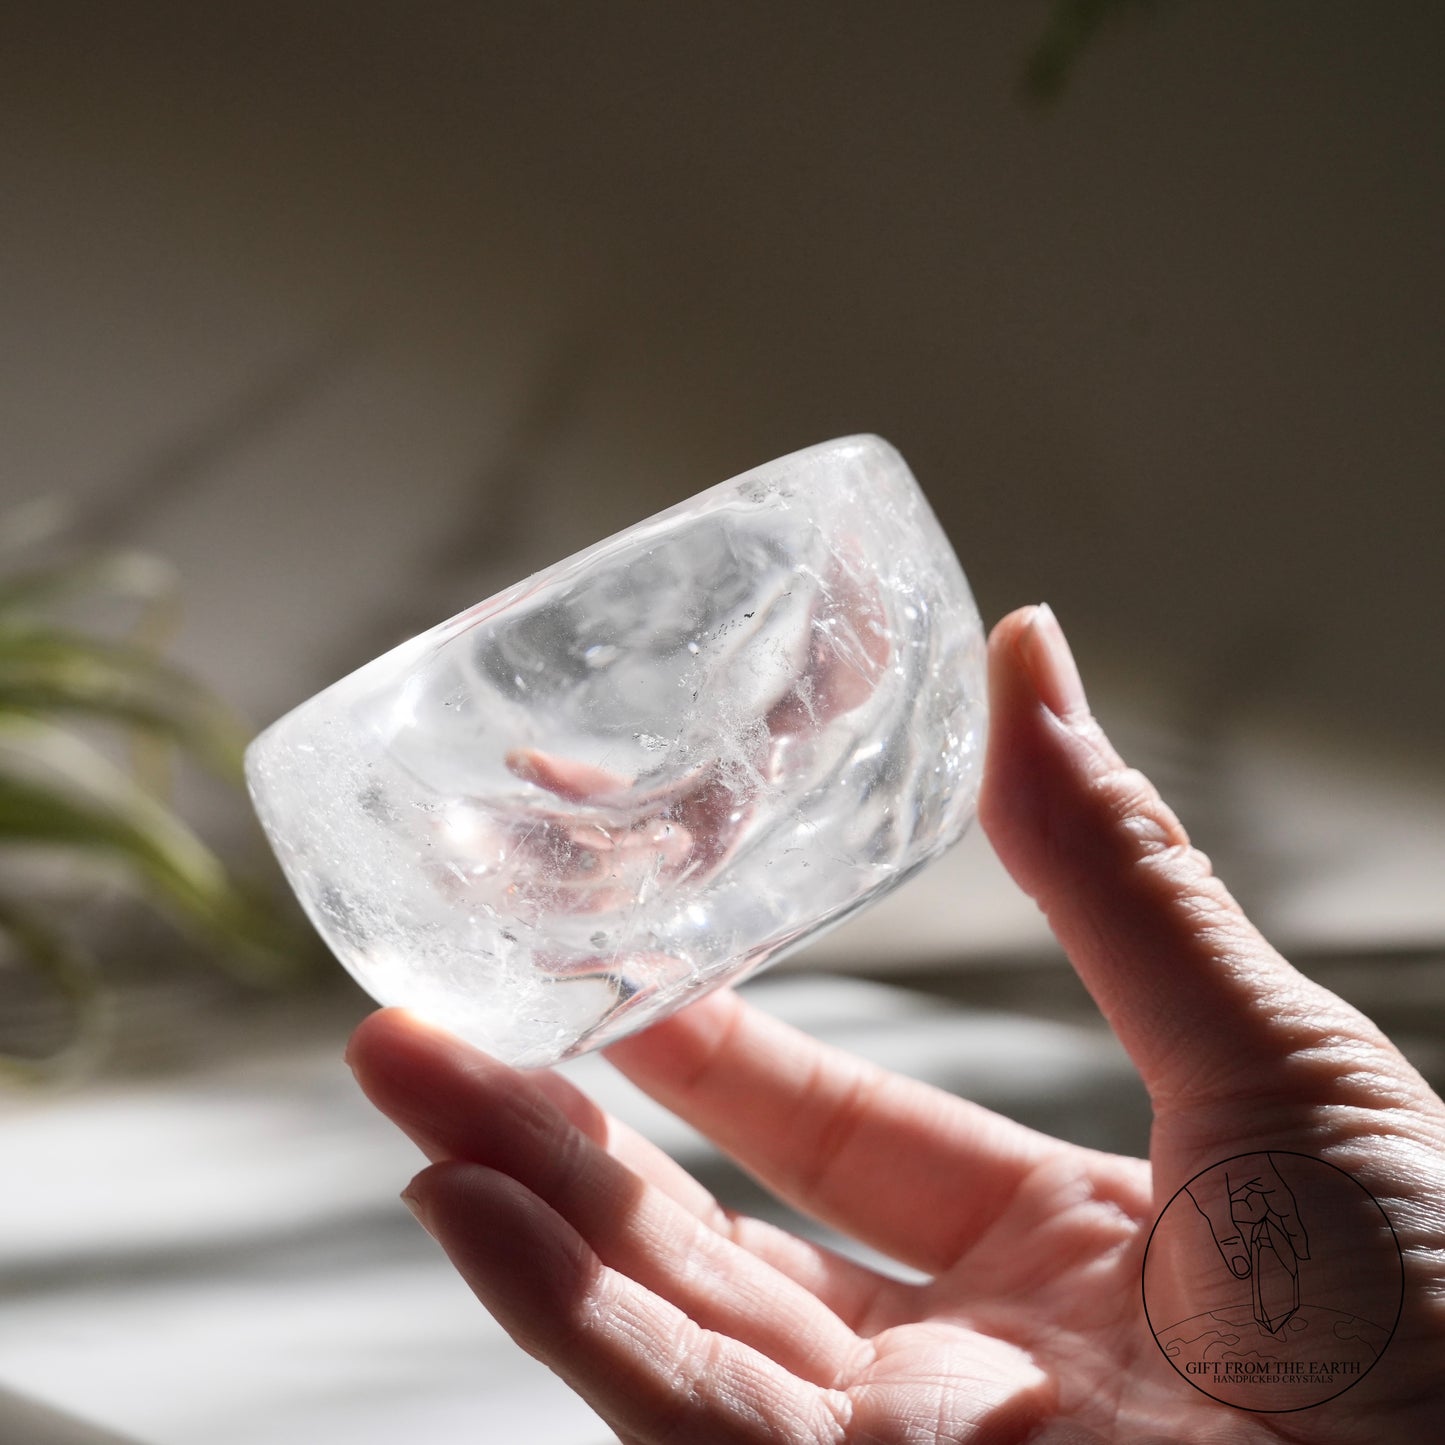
[0,0,1445,953]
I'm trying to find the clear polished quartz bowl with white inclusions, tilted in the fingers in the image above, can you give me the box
[247,436,984,1065]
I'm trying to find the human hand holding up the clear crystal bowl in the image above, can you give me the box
[350,610,1445,1445]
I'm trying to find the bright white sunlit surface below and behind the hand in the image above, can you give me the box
[0,977,1129,1445]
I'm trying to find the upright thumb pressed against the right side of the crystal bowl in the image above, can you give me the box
[978,607,1375,1114]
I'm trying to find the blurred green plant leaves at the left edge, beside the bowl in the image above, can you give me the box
[0,519,309,1077]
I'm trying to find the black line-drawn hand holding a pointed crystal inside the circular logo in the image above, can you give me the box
[1188,1155,1309,1335]
